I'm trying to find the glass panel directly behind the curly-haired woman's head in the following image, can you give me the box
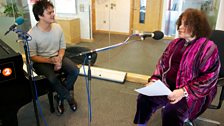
[162,0,220,37]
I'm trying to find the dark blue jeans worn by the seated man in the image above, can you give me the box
[33,57,79,101]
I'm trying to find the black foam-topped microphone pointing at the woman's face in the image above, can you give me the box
[139,31,164,40]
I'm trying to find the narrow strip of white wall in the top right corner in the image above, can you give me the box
[215,0,224,30]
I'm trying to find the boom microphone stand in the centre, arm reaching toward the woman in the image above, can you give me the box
[76,34,140,126]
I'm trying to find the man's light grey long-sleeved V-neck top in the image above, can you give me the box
[28,23,66,57]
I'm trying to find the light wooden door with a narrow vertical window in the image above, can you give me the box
[133,0,163,32]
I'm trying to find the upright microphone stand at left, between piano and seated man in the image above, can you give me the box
[13,29,40,126]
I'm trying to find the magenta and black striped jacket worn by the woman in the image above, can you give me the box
[153,37,220,120]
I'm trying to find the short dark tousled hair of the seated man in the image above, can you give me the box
[33,0,54,21]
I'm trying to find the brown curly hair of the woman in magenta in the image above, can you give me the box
[176,8,211,37]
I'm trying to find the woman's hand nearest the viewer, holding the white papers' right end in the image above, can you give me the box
[167,88,184,104]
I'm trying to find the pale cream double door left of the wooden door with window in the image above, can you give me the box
[94,0,131,34]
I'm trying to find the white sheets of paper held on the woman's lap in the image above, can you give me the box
[135,80,171,96]
